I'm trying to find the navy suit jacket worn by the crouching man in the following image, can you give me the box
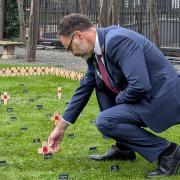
[63,26,180,132]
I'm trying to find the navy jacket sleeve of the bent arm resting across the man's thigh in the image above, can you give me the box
[109,37,151,104]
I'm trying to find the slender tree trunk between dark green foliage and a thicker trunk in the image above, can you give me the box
[17,0,26,45]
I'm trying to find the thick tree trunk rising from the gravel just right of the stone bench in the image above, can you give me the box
[26,0,39,62]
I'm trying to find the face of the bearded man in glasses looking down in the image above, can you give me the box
[60,31,92,59]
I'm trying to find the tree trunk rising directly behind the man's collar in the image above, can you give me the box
[98,0,112,27]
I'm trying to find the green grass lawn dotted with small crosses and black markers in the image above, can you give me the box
[0,76,180,180]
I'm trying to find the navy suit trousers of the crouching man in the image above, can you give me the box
[96,89,169,162]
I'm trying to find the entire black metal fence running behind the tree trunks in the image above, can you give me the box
[23,0,180,48]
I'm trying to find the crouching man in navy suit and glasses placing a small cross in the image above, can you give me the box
[48,14,180,178]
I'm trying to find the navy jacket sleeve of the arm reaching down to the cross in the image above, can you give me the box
[62,59,96,123]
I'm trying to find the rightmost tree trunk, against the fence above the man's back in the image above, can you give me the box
[149,0,160,48]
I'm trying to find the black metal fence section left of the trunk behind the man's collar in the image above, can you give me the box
[26,0,99,41]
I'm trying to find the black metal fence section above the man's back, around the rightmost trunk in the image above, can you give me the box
[118,0,180,48]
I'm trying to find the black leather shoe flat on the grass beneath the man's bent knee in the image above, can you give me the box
[89,145,136,161]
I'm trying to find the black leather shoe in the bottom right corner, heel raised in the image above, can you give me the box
[147,146,180,178]
